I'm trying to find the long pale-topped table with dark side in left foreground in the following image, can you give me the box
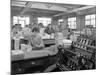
[11,48,58,74]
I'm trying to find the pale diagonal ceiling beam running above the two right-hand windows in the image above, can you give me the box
[53,6,96,17]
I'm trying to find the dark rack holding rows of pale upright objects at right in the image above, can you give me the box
[73,36,96,53]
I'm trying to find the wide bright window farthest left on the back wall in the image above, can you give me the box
[13,16,30,27]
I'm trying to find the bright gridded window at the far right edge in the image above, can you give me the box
[85,14,96,27]
